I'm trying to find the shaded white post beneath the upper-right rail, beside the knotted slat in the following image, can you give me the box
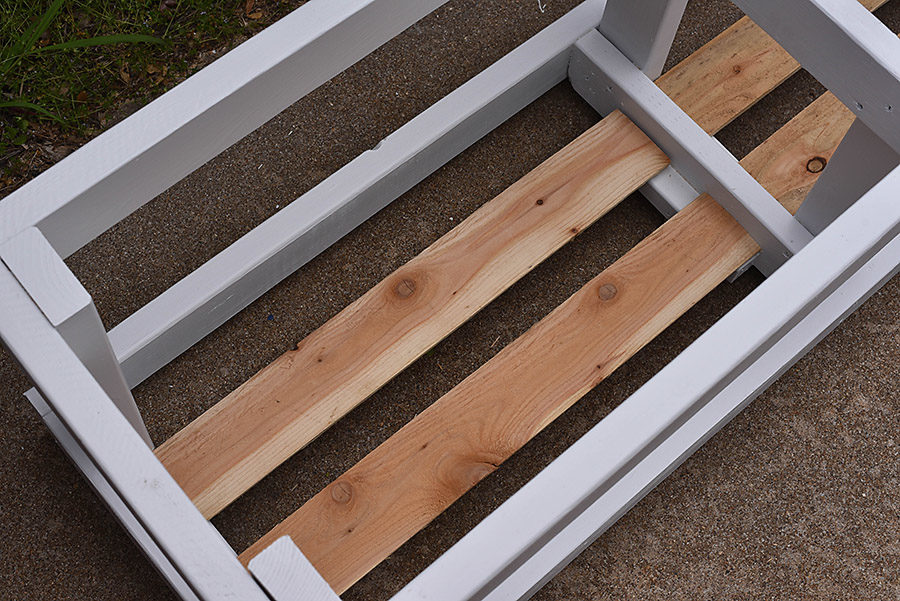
[795,119,900,235]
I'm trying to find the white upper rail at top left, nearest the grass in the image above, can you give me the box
[0,0,446,258]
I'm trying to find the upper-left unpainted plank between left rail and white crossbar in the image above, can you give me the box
[156,112,668,517]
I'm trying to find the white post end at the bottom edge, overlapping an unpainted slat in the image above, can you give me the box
[247,536,341,601]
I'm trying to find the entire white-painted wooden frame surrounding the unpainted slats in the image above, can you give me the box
[0,0,900,601]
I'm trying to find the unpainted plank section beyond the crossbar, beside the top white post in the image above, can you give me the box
[656,0,887,134]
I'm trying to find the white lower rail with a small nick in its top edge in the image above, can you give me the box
[109,0,605,386]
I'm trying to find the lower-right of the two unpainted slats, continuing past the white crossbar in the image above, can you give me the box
[240,94,852,593]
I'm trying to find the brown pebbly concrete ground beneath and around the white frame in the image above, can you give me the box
[0,0,900,601]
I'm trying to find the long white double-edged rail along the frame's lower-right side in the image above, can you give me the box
[394,169,900,601]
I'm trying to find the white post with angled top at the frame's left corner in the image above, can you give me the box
[0,227,153,449]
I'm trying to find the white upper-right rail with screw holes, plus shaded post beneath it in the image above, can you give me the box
[734,0,900,239]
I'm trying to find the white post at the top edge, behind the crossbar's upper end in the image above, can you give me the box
[598,0,687,79]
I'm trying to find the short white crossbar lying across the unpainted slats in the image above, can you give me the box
[569,31,812,273]
